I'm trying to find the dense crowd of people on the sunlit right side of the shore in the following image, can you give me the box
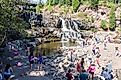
[63,32,121,80]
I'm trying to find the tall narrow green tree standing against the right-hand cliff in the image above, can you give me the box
[109,7,116,31]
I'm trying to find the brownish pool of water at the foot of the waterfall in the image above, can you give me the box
[38,41,77,55]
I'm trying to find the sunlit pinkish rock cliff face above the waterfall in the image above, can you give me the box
[43,5,121,29]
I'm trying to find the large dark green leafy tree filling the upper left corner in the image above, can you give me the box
[0,0,28,44]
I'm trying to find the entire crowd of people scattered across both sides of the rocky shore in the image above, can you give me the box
[0,31,121,80]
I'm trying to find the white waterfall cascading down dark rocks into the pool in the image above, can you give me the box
[60,18,81,47]
